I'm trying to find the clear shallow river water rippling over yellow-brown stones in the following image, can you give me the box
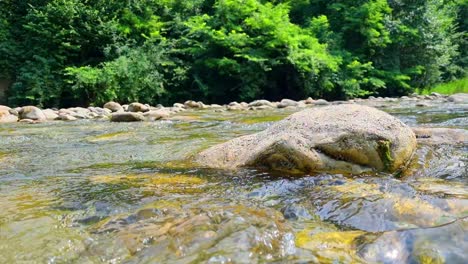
[0,102,468,263]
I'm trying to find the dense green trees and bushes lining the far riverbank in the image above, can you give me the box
[0,0,468,106]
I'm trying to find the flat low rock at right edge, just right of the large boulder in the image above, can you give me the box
[413,127,468,145]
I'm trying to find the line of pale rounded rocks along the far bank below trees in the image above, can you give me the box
[0,93,468,123]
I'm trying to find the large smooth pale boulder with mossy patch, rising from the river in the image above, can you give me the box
[195,105,416,173]
